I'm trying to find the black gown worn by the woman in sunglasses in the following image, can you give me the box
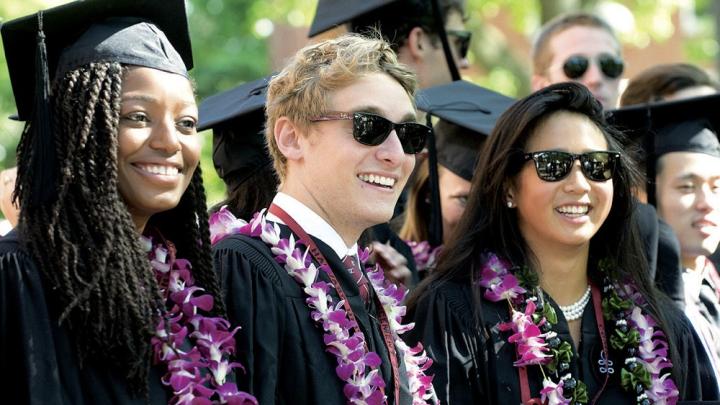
[405,282,718,405]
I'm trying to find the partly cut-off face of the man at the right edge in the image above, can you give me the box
[655,152,720,268]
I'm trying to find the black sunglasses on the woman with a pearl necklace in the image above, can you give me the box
[523,150,620,181]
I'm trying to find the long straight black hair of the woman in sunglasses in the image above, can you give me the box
[408,82,684,392]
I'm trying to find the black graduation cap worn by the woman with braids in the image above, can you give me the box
[0,0,192,207]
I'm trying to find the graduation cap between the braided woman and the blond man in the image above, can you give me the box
[198,76,272,190]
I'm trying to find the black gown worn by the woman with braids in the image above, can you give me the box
[0,231,171,405]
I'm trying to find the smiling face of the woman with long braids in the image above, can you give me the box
[117,67,200,231]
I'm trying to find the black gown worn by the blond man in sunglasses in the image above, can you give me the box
[214,225,412,404]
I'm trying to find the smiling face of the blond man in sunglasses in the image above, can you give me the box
[283,73,416,241]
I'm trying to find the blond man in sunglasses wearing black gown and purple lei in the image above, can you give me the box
[211,35,434,404]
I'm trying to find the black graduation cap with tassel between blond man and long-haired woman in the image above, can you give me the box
[415,80,515,246]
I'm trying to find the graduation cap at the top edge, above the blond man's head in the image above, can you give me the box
[308,0,460,80]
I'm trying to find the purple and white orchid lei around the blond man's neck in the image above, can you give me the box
[210,207,437,405]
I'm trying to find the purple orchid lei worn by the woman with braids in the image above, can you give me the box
[140,236,257,405]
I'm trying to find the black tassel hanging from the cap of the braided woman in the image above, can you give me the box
[29,11,57,205]
